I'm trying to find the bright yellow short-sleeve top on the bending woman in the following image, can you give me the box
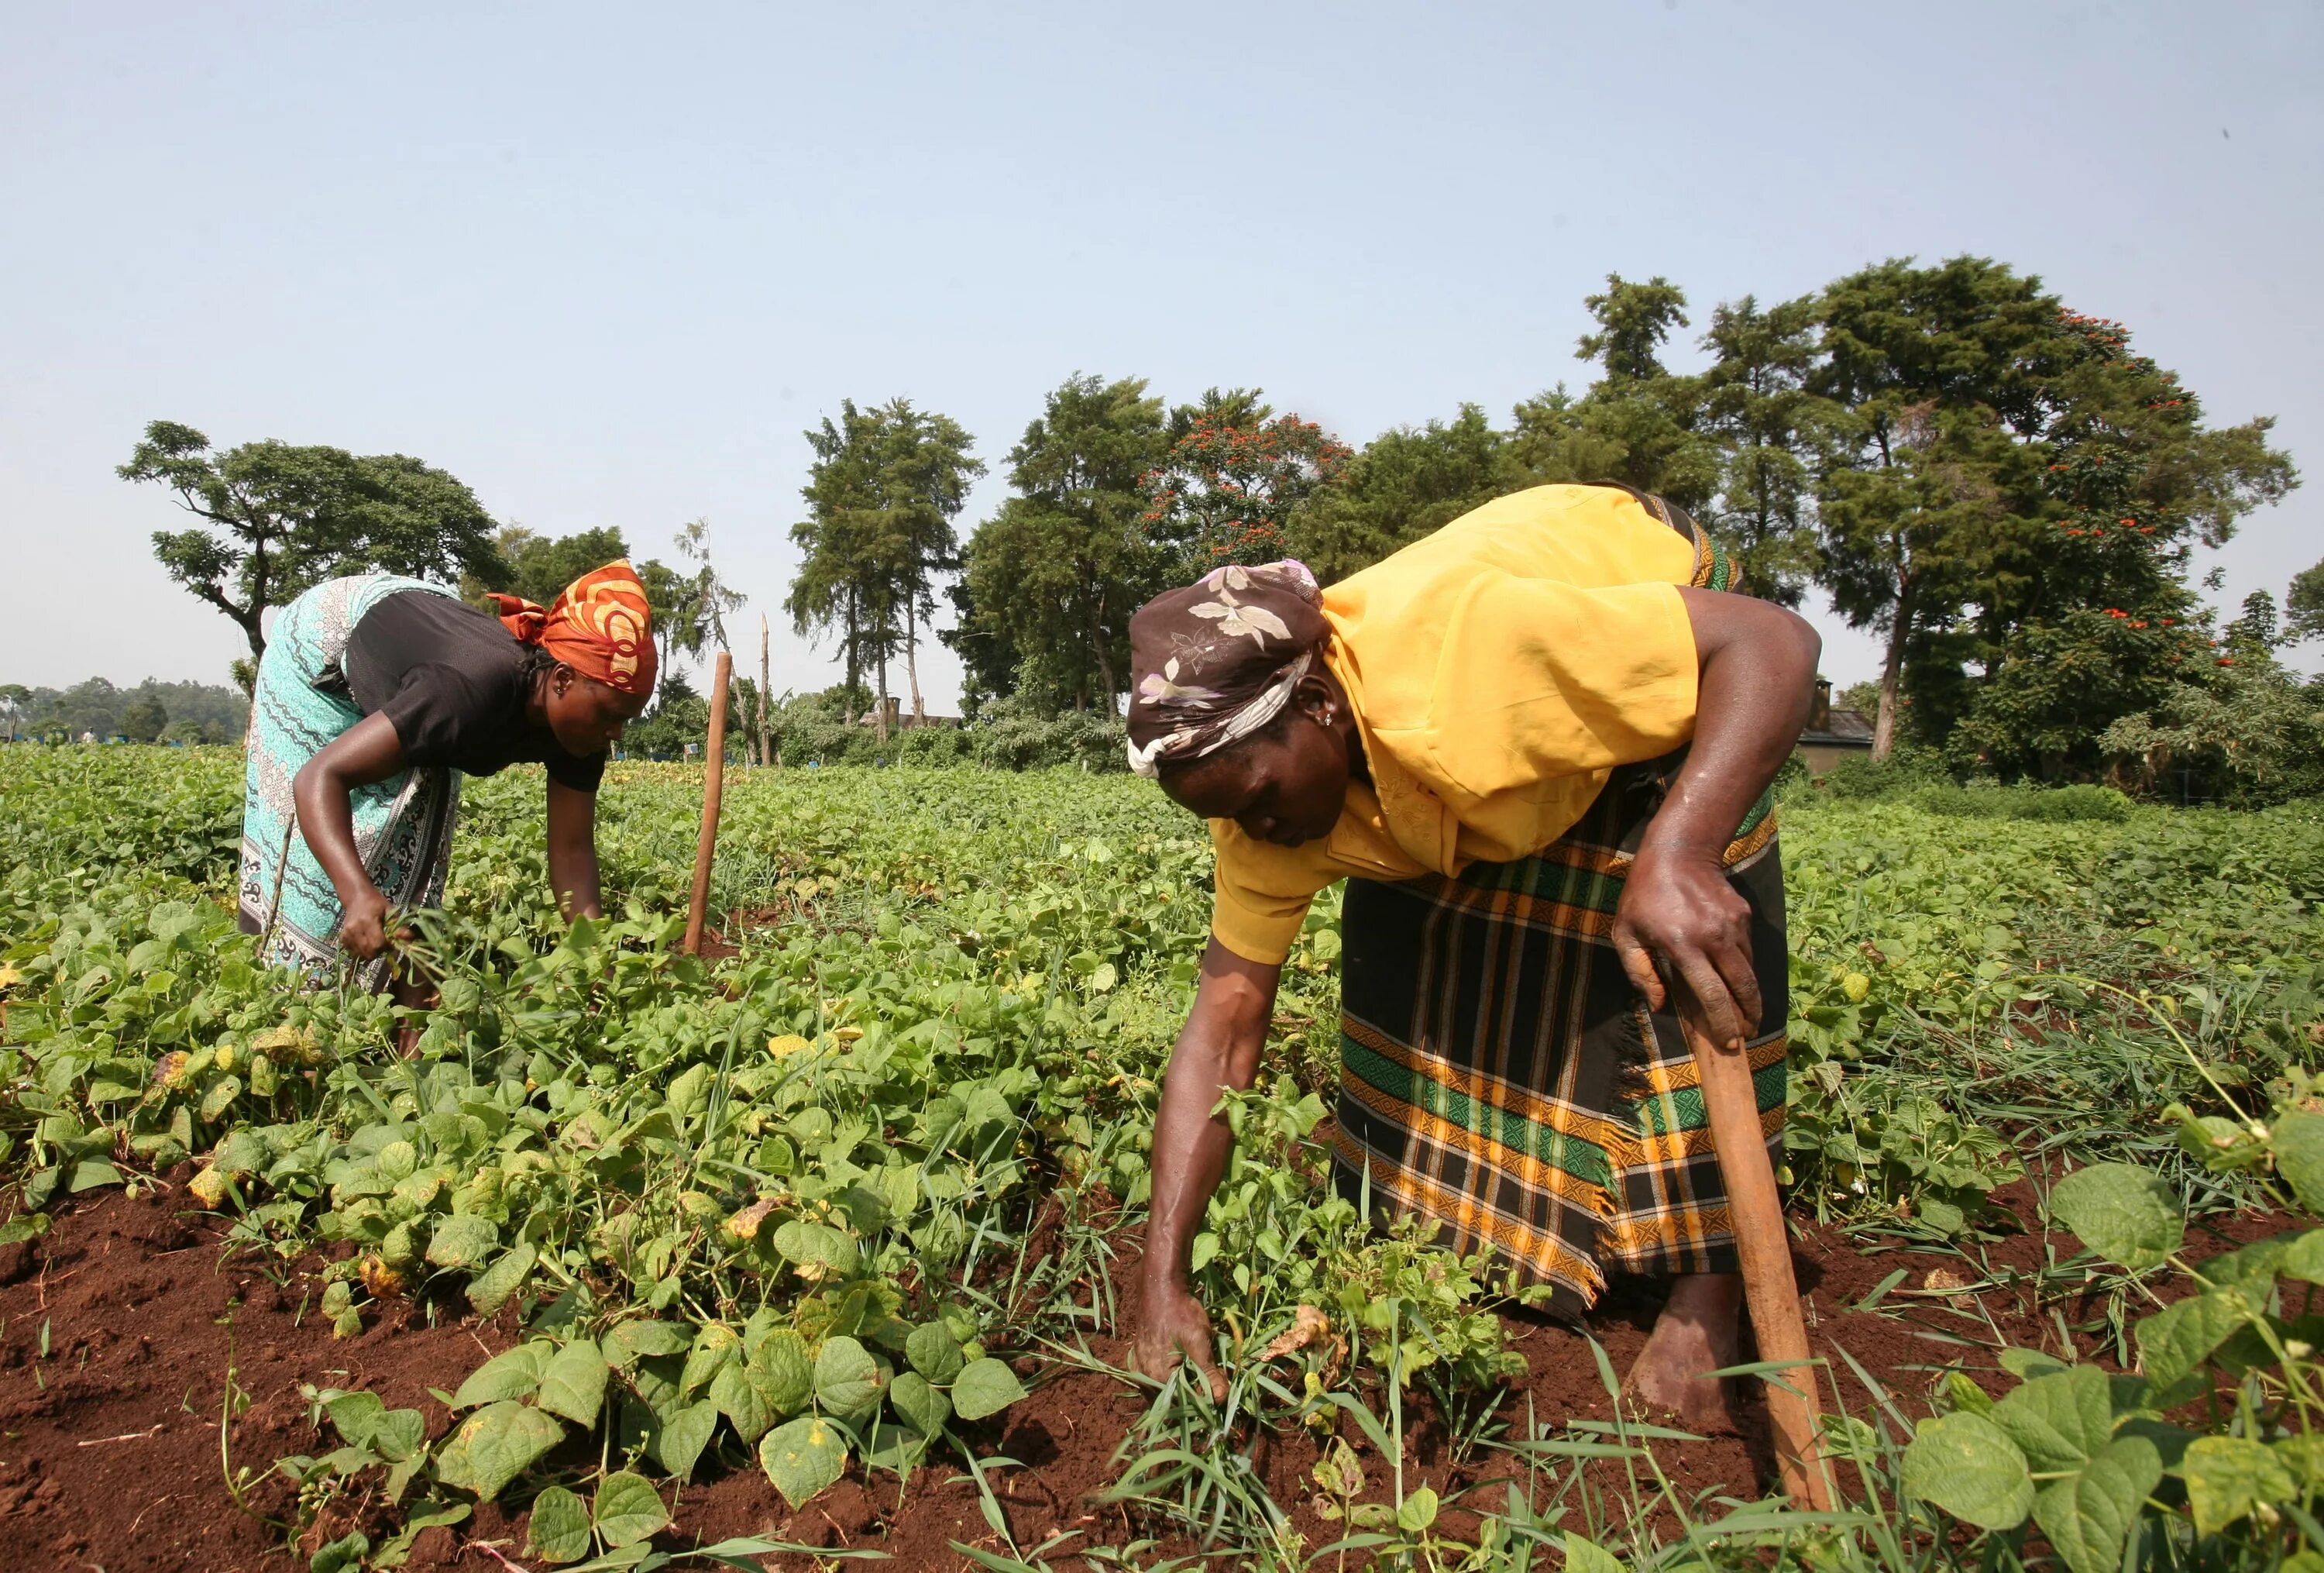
[1211,486,1697,962]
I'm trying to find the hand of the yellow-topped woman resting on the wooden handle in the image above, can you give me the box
[1613,848,1759,1048]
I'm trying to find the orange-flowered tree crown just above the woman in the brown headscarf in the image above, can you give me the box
[1139,388,1355,572]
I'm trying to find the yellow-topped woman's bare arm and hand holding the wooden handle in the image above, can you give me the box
[1613,586,1822,1048]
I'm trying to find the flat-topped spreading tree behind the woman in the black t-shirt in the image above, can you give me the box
[116,421,507,686]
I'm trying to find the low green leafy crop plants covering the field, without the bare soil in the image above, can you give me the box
[0,751,2324,1573]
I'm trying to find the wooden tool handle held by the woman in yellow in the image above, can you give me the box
[1680,1015,1831,1513]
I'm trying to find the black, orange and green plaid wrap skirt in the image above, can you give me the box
[1334,756,1787,1315]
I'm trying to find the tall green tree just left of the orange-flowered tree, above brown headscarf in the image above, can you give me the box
[955,377,1171,716]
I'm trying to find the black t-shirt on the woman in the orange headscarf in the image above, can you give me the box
[339,590,604,792]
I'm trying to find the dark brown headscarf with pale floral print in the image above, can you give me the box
[1129,558,1329,781]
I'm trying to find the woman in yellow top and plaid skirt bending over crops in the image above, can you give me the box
[1129,486,1820,1424]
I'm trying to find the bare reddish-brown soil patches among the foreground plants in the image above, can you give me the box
[0,1187,2284,1573]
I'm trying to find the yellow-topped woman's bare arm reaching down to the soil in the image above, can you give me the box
[1136,938,1283,1399]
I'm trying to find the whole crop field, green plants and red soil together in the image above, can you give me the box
[0,749,2324,1573]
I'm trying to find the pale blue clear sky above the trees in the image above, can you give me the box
[0,0,2324,709]
